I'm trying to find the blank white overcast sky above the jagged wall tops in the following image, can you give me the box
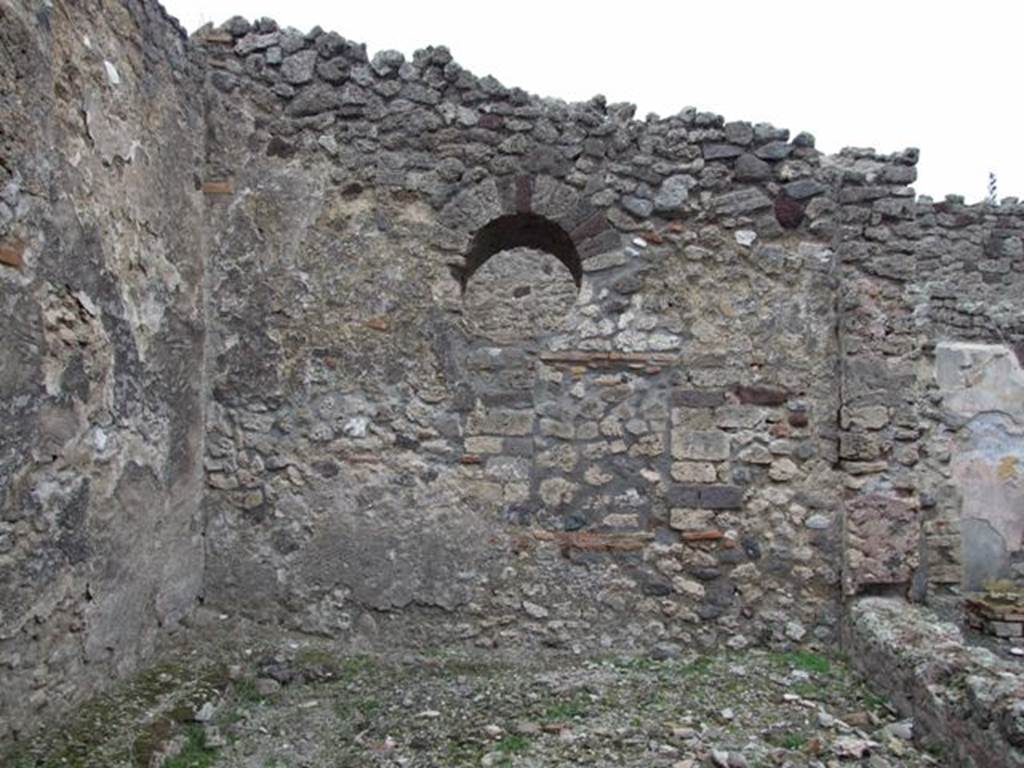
[164,0,1024,202]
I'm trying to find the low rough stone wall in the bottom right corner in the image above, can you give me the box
[843,597,1024,768]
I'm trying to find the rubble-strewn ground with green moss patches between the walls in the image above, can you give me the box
[0,640,940,768]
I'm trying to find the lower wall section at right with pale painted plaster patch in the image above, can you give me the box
[830,151,1024,597]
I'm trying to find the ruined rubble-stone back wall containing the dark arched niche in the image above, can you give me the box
[196,19,841,652]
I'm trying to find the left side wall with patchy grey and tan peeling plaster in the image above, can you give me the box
[0,0,204,740]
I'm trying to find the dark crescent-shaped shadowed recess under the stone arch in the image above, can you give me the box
[453,213,583,291]
